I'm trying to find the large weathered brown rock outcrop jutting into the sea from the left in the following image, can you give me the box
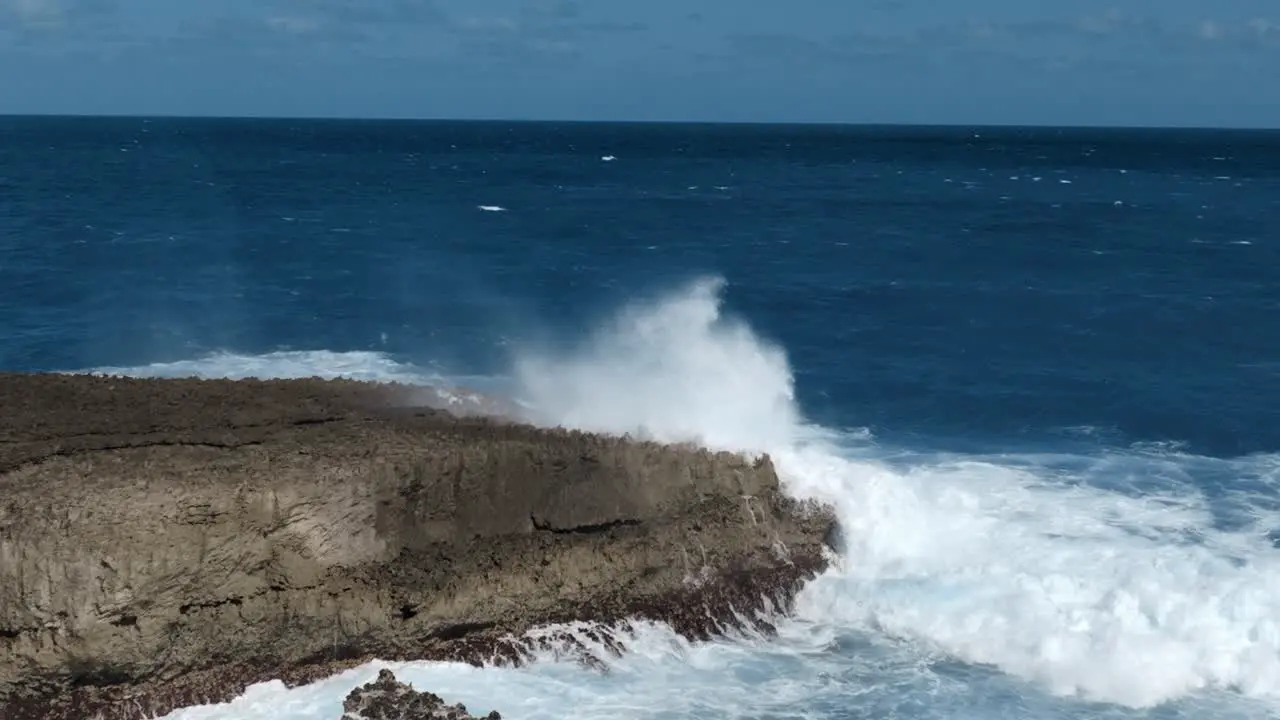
[0,375,833,720]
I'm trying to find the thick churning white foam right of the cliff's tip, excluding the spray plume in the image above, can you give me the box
[778,450,1280,707]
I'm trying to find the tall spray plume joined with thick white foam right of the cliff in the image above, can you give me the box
[494,281,1280,707]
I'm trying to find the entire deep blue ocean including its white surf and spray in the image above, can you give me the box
[0,118,1280,720]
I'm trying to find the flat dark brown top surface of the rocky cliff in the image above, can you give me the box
[0,373,696,476]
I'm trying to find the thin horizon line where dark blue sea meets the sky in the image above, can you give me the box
[0,113,1280,132]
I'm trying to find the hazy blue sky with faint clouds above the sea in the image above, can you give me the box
[0,0,1280,127]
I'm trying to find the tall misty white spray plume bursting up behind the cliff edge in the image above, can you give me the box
[513,279,799,451]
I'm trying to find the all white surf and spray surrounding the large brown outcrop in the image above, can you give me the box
[100,275,1280,720]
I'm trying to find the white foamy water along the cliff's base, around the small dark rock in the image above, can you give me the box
[168,623,842,720]
